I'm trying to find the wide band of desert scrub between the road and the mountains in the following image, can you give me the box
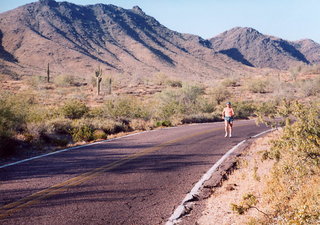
[0,67,320,157]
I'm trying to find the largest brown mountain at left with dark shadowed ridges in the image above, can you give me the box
[0,0,250,79]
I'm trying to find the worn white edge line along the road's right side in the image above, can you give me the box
[166,129,275,225]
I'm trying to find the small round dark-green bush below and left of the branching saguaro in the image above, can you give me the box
[60,100,89,119]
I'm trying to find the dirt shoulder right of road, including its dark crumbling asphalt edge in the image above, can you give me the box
[179,131,279,225]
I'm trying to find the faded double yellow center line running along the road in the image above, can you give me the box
[0,125,250,220]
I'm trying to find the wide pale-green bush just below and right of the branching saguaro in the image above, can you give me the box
[102,96,151,120]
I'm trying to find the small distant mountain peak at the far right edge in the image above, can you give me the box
[291,39,320,64]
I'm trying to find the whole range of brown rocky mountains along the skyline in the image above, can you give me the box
[0,0,318,80]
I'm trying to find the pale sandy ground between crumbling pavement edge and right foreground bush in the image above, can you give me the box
[195,131,279,225]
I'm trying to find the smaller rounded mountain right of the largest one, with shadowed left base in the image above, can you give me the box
[210,27,312,69]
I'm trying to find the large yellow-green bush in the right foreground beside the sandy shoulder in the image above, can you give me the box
[260,102,320,224]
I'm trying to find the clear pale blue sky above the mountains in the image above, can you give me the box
[0,0,320,43]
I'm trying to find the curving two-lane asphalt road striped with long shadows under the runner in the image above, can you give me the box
[0,121,267,225]
